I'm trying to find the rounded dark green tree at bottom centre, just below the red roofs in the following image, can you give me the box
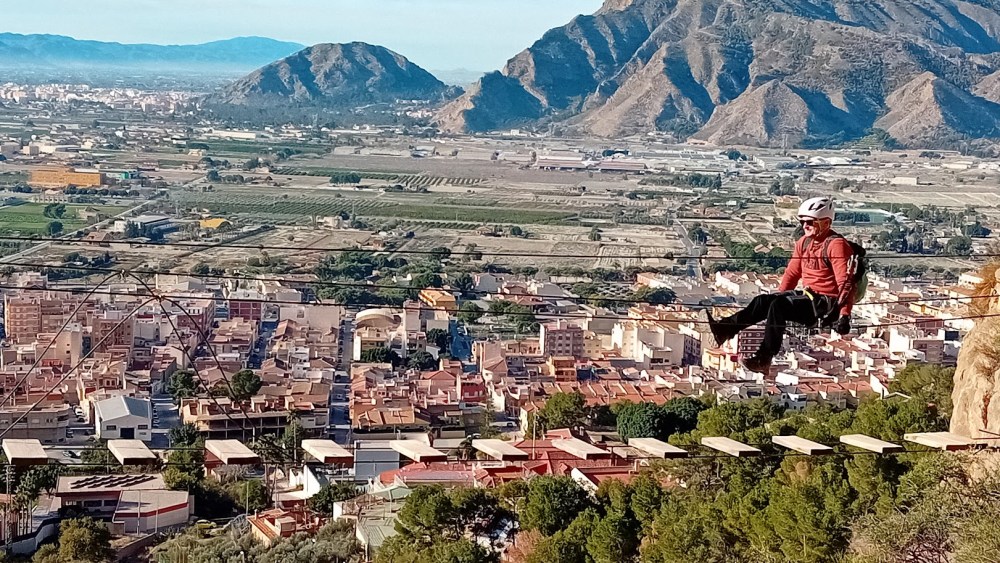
[520,476,591,536]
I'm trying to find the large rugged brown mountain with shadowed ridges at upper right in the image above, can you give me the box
[438,0,1000,147]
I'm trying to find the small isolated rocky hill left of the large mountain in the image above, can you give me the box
[217,43,460,106]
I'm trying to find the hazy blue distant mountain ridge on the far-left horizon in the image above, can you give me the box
[0,33,303,72]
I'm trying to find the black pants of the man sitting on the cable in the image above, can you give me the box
[719,291,837,359]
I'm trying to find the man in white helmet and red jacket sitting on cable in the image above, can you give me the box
[708,197,856,374]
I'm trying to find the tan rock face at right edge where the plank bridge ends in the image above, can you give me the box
[951,270,1000,443]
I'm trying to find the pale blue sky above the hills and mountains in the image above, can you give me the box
[0,0,602,71]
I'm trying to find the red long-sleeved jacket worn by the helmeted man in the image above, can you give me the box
[778,231,854,315]
